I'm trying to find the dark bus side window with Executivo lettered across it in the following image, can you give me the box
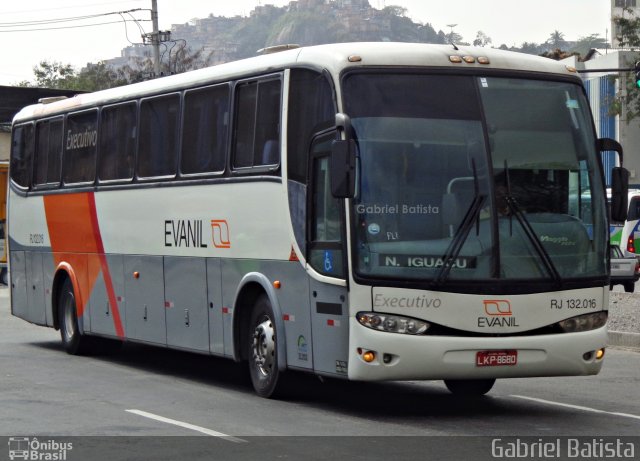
[62,110,98,184]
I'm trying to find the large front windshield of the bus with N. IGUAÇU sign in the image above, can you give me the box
[344,71,608,285]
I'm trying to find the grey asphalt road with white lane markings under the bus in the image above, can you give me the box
[0,287,640,460]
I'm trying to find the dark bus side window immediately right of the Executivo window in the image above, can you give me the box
[98,102,137,181]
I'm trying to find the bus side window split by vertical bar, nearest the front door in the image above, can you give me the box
[232,79,282,168]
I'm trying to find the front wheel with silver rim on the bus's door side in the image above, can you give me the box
[247,295,282,398]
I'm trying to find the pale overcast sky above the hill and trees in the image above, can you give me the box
[0,0,611,85]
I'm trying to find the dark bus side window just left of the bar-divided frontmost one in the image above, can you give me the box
[180,84,229,174]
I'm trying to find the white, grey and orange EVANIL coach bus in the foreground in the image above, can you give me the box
[9,43,628,397]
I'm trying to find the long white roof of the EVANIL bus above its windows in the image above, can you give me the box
[14,42,578,123]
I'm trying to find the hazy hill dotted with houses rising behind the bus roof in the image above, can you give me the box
[165,0,445,64]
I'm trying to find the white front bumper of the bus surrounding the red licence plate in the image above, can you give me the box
[348,318,607,381]
